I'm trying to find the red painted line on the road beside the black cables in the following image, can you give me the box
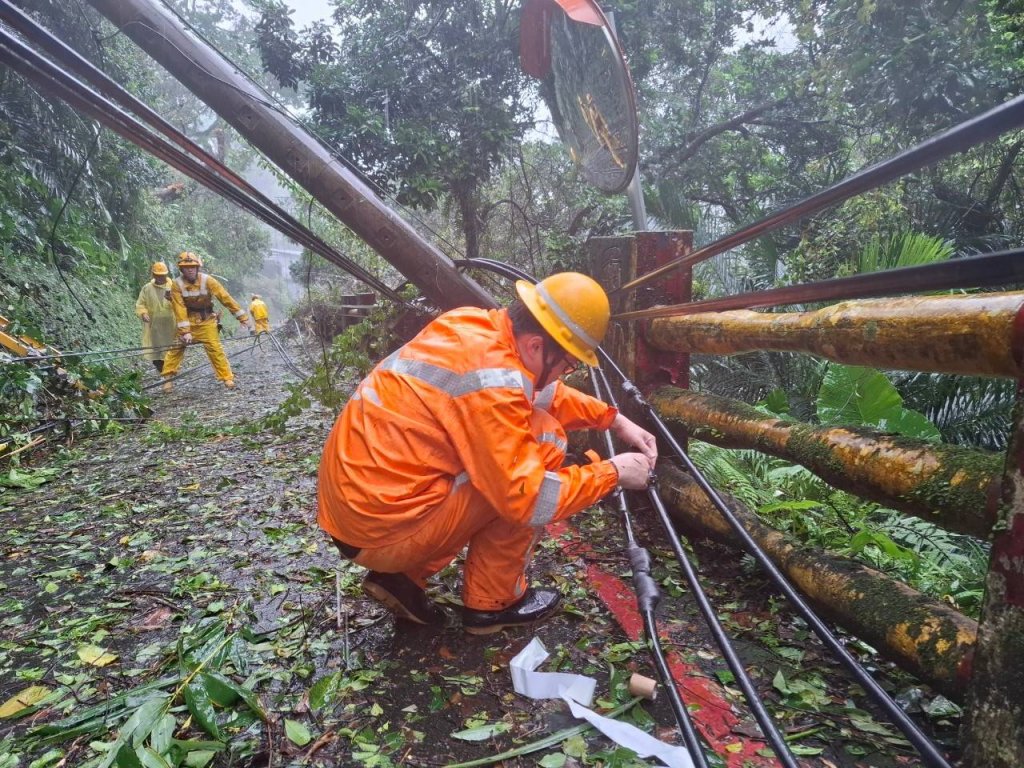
[548,521,779,768]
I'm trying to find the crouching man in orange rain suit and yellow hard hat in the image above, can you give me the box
[317,272,657,634]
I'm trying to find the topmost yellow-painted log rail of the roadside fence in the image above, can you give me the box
[647,293,1024,378]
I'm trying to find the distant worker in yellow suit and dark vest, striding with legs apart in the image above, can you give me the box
[163,251,249,392]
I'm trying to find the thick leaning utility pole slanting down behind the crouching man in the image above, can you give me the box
[89,0,497,309]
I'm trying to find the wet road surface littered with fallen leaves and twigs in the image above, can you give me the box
[0,335,956,768]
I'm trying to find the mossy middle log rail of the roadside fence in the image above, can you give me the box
[650,387,1004,539]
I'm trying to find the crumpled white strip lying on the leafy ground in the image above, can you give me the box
[509,637,693,768]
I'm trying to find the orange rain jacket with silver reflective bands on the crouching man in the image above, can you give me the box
[317,307,617,548]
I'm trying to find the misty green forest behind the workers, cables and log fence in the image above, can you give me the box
[0,0,1024,612]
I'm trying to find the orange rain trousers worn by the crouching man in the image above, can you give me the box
[344,409,566,610]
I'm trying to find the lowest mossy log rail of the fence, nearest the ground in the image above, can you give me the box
[658,466,978,701]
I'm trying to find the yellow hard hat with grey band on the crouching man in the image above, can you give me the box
[515,272,611,366]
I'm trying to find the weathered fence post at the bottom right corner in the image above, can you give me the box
[963,382,1024,768]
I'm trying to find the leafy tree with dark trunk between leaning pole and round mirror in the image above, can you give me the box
[258,0,528,256]
